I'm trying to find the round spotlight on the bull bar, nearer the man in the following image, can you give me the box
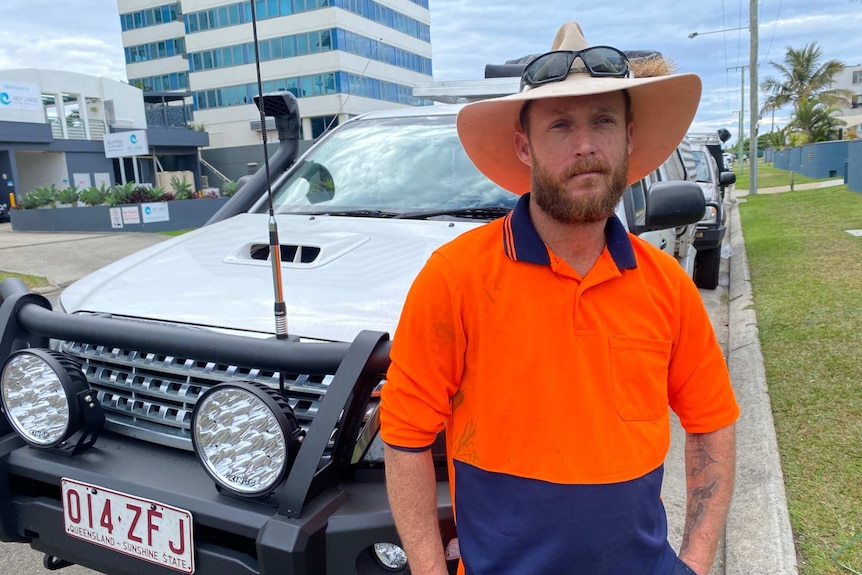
[192,381,299,497]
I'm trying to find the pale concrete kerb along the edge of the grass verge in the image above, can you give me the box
[725,200,799,575]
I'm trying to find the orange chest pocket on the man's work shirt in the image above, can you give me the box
[609,336,671,421]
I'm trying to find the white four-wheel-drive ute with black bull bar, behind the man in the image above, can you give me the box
[0,96,705,575]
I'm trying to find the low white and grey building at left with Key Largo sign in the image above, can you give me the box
[0,69,208,203]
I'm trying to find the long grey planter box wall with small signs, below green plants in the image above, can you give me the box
[10,198,230,232]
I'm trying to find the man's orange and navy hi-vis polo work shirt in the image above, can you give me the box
[381,194,739,575]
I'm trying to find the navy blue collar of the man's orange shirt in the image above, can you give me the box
[503,194,637,271]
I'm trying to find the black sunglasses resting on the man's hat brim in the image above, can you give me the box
[521,46,631,90]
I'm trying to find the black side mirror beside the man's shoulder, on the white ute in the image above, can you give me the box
[637,180,706,234]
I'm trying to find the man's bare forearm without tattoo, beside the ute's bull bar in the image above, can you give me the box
[384,446,448,575]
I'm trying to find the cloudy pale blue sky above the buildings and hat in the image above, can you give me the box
[0,0,862,147]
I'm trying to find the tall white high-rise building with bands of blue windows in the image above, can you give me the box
[117,0,431,148]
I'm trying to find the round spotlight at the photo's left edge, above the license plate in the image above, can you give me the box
[0,349,89,447]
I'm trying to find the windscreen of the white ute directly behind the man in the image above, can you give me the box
[266,115,518,214]
